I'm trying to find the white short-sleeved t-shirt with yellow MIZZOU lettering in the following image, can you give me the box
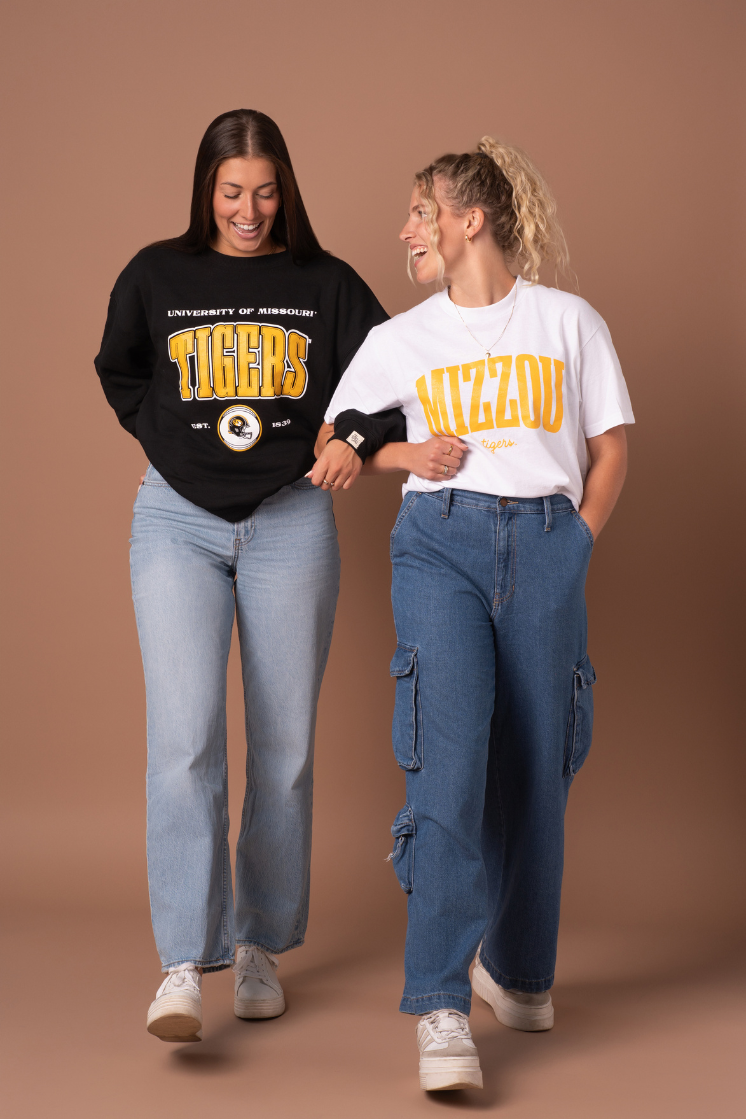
[327,278,634,509]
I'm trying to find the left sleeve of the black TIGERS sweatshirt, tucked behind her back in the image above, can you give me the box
[94,265,155,436]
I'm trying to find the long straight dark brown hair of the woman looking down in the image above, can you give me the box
[157,109,323,264]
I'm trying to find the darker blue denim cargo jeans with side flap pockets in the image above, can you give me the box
[391,490,595,1014]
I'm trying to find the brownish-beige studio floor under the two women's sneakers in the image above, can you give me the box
[2,913,746,1119]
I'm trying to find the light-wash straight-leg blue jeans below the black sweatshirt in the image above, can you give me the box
[131,467,339,971]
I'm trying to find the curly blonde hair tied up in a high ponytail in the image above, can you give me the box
[407,137,570,284]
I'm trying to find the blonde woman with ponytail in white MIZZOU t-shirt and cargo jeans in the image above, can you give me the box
[312,137,634,1090]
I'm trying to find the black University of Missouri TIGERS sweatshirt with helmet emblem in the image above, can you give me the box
[95,245,406,521]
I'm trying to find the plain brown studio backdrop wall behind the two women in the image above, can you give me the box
[0,0,744,1117]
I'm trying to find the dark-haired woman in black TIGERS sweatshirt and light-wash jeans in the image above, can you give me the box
[96,109,400,1042]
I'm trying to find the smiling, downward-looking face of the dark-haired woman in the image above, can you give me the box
[213,159,282,256]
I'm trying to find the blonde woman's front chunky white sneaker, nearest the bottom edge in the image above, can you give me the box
[417,1010,482,1092]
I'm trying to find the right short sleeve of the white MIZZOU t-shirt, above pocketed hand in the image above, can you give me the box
[580,321,634,439]
